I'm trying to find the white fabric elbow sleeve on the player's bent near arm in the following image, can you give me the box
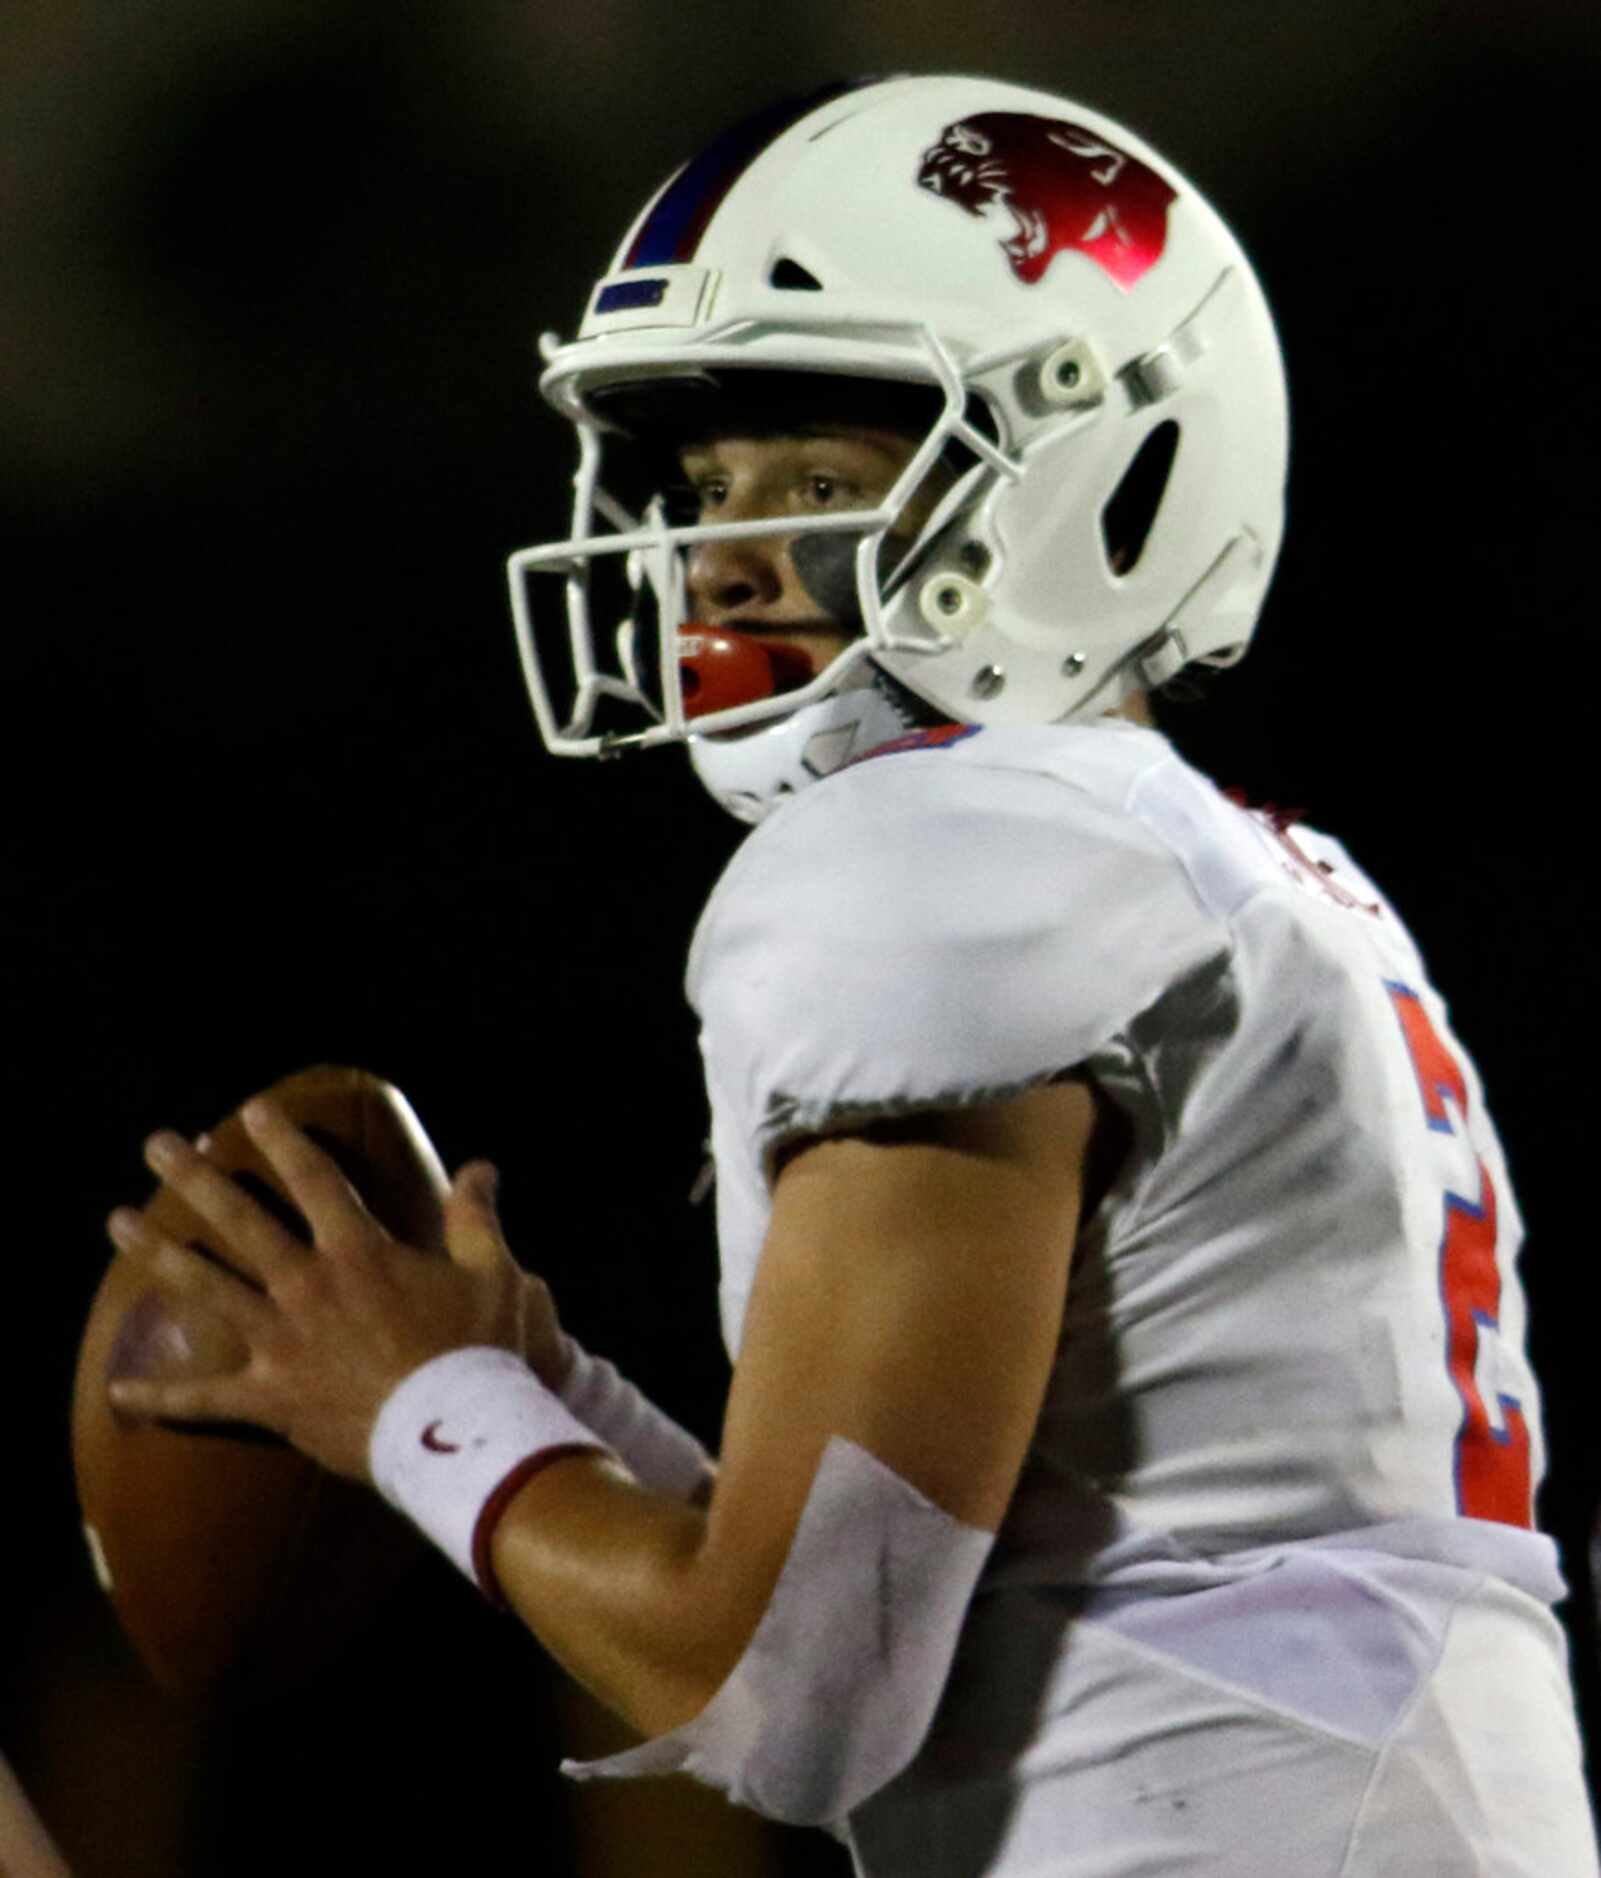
[561,1435,995,1825]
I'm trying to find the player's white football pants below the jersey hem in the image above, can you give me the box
[848,1555,1597,1878]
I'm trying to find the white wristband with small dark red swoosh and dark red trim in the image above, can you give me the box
[368,1347,606,1604]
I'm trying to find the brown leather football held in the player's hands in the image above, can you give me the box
[73,1069,449,1701]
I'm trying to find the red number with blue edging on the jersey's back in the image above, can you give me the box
[1385,980,1533,1527]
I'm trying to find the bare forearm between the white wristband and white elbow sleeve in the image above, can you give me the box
[492,1455,762,1735]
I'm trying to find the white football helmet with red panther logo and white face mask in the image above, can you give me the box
[509,77,1288,821]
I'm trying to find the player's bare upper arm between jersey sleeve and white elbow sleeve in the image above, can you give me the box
[708,1082,1094,1607]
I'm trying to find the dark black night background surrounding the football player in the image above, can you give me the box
[0,0,1601,1878]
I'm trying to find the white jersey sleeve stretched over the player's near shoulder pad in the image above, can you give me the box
[689,751,1227,1172]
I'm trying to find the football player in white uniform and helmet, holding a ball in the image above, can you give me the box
[114,77,1597,1878]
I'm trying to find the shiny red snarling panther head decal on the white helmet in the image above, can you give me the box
[918,111,1177,287]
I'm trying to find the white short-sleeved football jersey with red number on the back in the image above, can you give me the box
[689,719,1565,1604]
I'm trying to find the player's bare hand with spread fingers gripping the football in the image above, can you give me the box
[107,1102,529,1480]
